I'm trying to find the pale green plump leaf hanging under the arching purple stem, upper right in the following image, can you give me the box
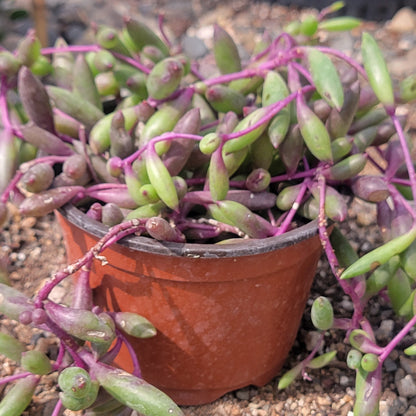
[307,48,344,111]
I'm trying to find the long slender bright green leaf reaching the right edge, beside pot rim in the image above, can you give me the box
[341,227,416,279]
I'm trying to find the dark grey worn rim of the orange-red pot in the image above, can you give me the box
[57,204,319,258]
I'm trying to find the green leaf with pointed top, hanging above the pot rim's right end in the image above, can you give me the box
[297,94,332,162]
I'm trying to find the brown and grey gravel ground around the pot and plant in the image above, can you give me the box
[0,0,416,416]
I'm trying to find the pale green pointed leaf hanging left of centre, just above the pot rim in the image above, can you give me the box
[146,146,179,210]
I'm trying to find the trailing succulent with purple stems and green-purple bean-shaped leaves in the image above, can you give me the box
[0,2,416,416]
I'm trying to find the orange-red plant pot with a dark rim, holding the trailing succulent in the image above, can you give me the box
[57,207,321,405]
